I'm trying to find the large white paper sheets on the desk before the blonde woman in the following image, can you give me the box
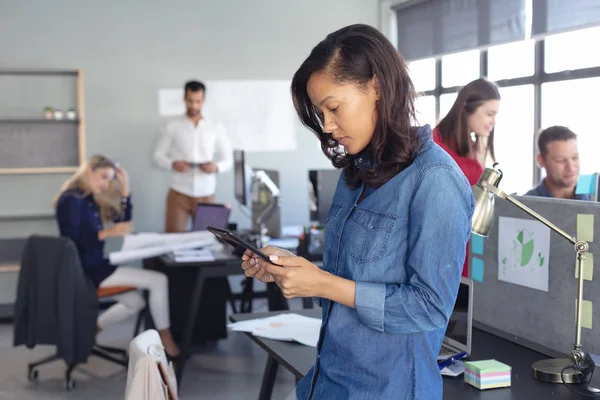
[108,231,217,265]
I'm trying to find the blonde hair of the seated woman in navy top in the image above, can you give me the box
[52,154,122,222]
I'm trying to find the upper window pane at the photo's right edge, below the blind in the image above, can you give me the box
[544,27,600,73]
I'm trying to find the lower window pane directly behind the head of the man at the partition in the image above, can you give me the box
[542,77,600,174]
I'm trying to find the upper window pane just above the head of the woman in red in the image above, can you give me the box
[488,40,535,81]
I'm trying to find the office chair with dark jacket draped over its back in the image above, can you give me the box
[14,235,141,390]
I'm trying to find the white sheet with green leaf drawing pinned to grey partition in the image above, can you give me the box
[498,217,550,292]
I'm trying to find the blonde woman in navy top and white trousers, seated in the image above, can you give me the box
[54,155,179,358]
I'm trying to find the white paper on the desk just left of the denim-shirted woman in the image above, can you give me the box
[227,313,321,347]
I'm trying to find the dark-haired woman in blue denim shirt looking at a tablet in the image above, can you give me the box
[242,25,475,400]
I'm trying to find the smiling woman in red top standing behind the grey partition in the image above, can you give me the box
[433,78,500,277]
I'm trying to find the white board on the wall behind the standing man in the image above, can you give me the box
[158,80,297,151]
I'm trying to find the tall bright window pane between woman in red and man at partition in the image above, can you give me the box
[494,85,535,194]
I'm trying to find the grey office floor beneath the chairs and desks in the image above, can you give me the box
[0,301,301,400]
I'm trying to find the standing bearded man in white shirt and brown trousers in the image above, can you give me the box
[154,81,233,232]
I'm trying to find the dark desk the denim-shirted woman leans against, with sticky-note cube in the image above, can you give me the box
[230,309,584,400]
